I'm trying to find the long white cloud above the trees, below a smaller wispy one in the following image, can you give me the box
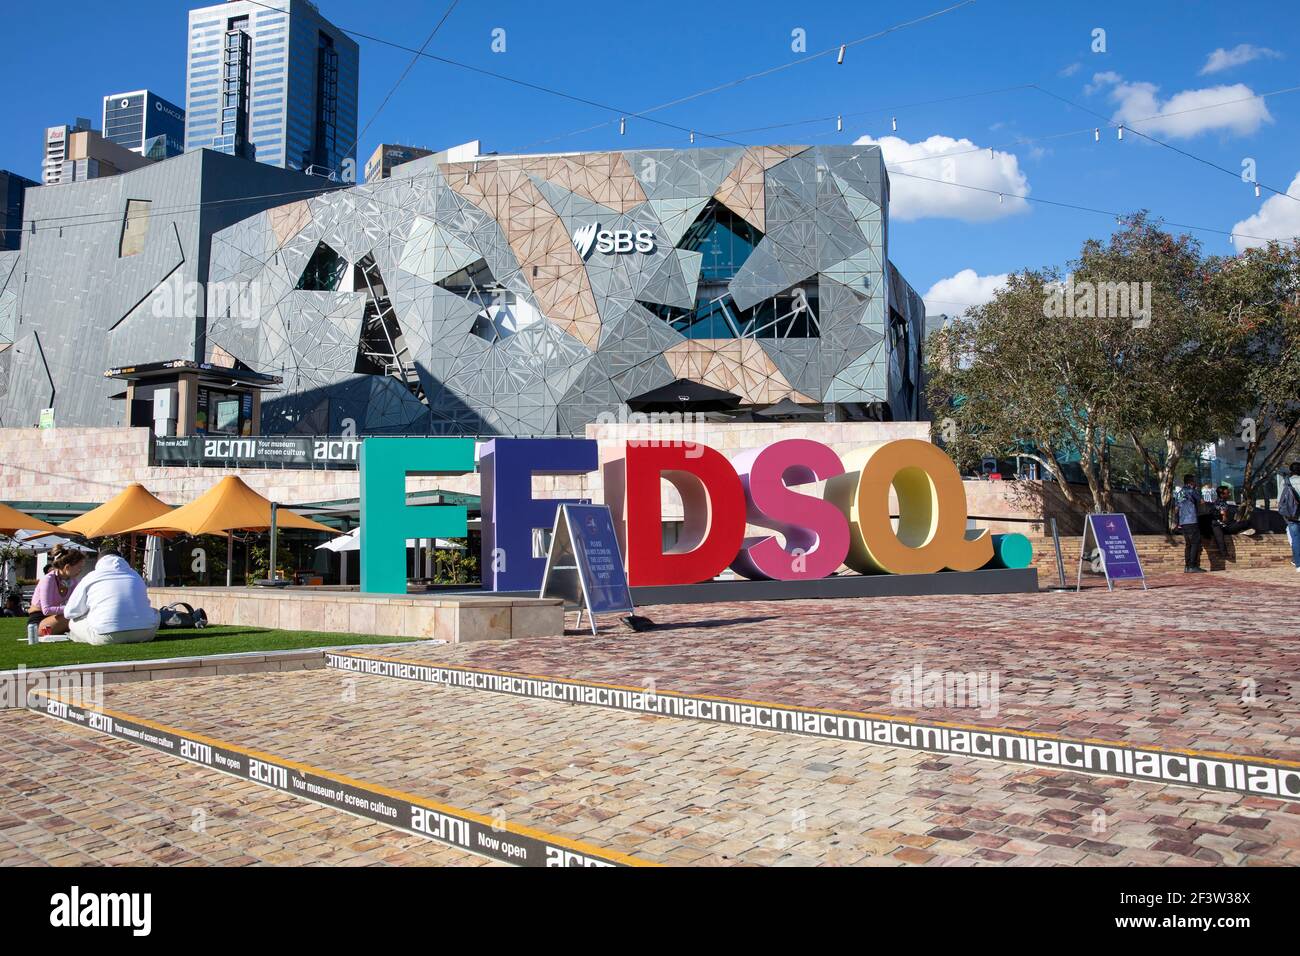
[1084,73,1273,139]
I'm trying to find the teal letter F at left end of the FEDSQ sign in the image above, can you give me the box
[361,438,475,594]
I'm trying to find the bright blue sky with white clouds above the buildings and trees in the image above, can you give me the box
[0,0,1300,312]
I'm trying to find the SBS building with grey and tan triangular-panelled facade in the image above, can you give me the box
[205,146,924,436]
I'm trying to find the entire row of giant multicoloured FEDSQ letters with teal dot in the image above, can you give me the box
[360,437,1032,594]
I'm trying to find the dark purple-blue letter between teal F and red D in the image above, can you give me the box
[478,438,599,591]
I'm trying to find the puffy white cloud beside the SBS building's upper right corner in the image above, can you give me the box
[857,137,1030,222]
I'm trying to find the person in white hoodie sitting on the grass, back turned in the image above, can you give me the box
[64,545,159,644]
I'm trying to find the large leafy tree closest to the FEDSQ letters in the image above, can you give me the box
[927,212,1268,522]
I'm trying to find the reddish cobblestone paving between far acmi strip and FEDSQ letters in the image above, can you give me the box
[361,568,1300,760]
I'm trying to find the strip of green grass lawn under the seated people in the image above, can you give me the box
[0,618,408,670]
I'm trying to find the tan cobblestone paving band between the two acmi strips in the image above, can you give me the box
[7,671,1300,865]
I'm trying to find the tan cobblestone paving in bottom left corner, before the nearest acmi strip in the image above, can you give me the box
[0,712,488,866]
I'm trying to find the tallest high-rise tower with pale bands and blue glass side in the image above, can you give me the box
[185,0,359,179]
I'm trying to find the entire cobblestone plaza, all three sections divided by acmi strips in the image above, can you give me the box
[0,570,1300,865]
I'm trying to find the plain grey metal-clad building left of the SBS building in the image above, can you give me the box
[0,150,332,428]
